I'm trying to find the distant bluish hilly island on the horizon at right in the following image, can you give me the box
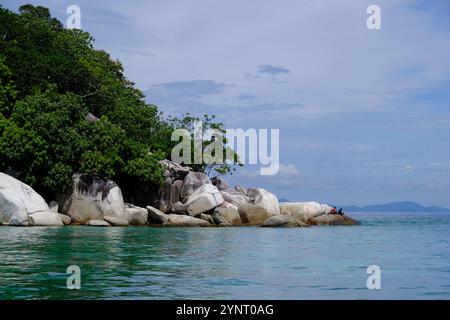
[279,198,450,212]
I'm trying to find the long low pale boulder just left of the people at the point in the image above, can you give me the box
[280,202,331,223]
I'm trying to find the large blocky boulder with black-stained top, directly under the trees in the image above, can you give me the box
[62,174,125,224]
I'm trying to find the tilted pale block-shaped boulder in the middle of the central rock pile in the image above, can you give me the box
[186,184,224,216]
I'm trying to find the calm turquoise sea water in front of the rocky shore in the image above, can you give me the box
[0,213,450,299]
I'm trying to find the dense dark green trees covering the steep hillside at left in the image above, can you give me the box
[0,5,239,201]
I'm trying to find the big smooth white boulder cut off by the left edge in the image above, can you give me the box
[0,173,50,226]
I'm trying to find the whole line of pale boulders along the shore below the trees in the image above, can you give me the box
[0,160,358,227]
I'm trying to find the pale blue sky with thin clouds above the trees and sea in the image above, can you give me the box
[0,0,450,207]
